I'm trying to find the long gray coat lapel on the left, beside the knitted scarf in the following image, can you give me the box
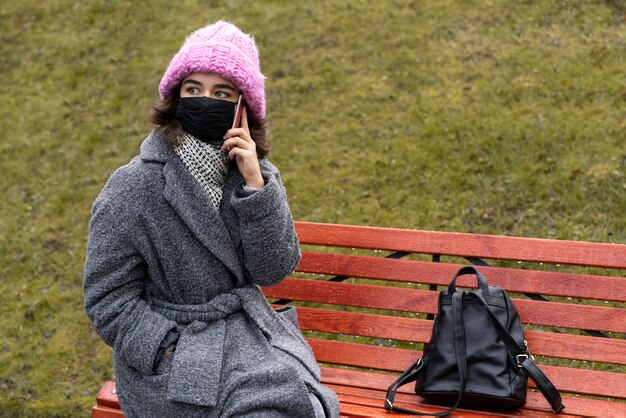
[141,132,243,280]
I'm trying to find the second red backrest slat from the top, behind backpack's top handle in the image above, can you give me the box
[296,251,626,302]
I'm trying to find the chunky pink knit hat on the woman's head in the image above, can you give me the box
[159,20,265,118]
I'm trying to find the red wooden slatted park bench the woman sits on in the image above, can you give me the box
[92,222,626,417]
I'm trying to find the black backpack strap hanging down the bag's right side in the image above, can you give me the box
[465,292,565,414]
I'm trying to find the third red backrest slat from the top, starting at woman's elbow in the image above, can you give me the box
[263,278,626,332]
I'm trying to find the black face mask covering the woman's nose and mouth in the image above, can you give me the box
[176,96,235,143]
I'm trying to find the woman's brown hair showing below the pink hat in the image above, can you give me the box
[150,84,272,159]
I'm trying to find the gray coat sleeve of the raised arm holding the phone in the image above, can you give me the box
[231,160,301,286]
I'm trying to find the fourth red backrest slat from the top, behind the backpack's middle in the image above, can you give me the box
[290,307,626,364]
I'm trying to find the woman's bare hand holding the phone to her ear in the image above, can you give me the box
[222,107,265,189]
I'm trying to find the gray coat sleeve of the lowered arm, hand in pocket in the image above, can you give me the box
[83,199,176,375]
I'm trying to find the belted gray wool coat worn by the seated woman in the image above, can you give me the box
[84,132,338,418]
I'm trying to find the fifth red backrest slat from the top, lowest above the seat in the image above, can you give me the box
[308,338,626,399]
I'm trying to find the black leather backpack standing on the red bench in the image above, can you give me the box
[385,266,564,416]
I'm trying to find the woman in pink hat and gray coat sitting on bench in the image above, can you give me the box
[84,21,338,417]
